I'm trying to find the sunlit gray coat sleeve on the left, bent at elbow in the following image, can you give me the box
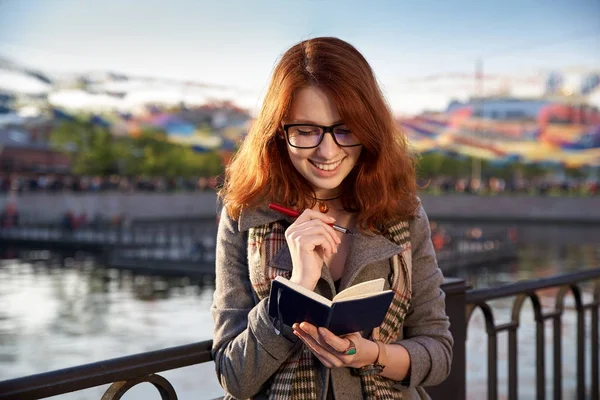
[211,209,295,399]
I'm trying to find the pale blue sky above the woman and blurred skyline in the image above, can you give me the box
[0,0,600,112]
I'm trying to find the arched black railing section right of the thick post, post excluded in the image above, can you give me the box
[466,269,600,400]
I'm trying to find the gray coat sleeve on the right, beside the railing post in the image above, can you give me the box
[397,206,454,389]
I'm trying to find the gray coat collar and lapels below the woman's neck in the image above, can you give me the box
[238,203,403,288]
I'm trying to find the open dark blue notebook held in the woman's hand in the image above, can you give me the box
[269,277,394,336]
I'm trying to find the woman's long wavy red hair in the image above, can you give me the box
[219,37,418,231]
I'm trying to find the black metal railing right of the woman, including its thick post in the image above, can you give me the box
[428,268,600,400]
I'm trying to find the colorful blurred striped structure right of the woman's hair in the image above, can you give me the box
[398,96,600,167]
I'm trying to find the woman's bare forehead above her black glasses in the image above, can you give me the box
[288,86,341,125]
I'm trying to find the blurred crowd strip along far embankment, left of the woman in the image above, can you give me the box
[0,174,219,193]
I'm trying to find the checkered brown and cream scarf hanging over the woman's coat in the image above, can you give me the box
[248,221,411,400]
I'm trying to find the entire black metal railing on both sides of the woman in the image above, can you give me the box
[0,268,600,400]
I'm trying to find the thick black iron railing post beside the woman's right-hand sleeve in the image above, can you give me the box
[427,278,469,400]
